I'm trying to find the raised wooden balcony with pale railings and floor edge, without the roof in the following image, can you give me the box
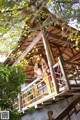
[14,59,80,112]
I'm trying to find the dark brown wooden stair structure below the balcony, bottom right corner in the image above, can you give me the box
[48,97,80,120]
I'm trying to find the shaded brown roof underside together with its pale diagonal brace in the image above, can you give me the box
[5,7,80,77]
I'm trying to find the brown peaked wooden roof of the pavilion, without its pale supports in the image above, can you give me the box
[5,8,80,78]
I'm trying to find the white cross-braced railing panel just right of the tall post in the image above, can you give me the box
[53,58,69,93]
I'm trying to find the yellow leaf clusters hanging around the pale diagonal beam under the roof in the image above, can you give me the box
[10,46,42,66]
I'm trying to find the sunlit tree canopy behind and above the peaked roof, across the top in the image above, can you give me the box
[0,0,80,54]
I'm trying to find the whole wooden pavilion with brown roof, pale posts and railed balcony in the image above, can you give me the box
[5,9,80,112]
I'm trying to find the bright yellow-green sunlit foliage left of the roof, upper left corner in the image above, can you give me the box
[0,0,28,54]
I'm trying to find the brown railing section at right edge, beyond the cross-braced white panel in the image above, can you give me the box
[64,62,80,90]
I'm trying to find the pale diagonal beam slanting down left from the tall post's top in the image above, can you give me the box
[13,32,42,66]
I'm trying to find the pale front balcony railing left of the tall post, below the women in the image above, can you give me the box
[14,76,55,112]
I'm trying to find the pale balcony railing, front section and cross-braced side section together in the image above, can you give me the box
[14,58,80,112]
